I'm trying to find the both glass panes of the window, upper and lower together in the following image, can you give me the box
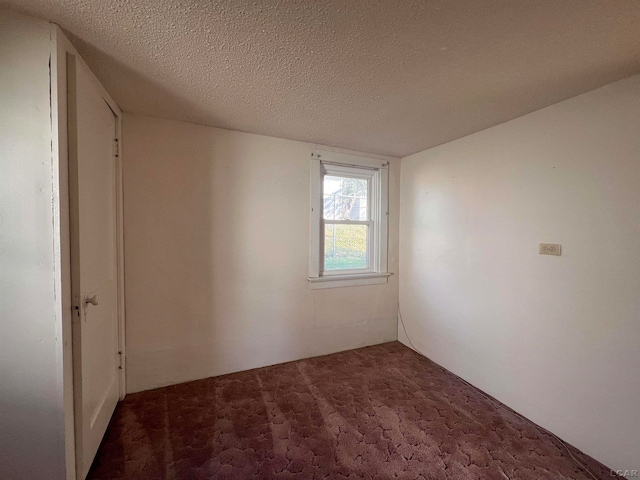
[323,175,369,270]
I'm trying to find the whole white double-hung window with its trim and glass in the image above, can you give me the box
[309,152,389,288]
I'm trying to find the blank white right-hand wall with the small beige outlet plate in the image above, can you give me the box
[400,76,640,469]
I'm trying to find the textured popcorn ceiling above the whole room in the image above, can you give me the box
[0,0,640,156]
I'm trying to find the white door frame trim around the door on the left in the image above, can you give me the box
[50,24,126,480]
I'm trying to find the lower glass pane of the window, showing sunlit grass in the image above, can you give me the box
[324,224,369,270]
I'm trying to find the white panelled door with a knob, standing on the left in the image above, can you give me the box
[67,55,120,479]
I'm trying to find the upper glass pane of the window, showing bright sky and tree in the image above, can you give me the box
[323,175,368,220]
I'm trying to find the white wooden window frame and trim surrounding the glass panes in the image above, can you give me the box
[308,151,390,289]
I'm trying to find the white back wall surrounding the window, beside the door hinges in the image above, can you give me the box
[123,115,399,392]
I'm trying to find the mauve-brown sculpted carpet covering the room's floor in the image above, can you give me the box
[89,342,611,480]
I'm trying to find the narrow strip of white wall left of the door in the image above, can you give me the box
[0,10,65,480]
